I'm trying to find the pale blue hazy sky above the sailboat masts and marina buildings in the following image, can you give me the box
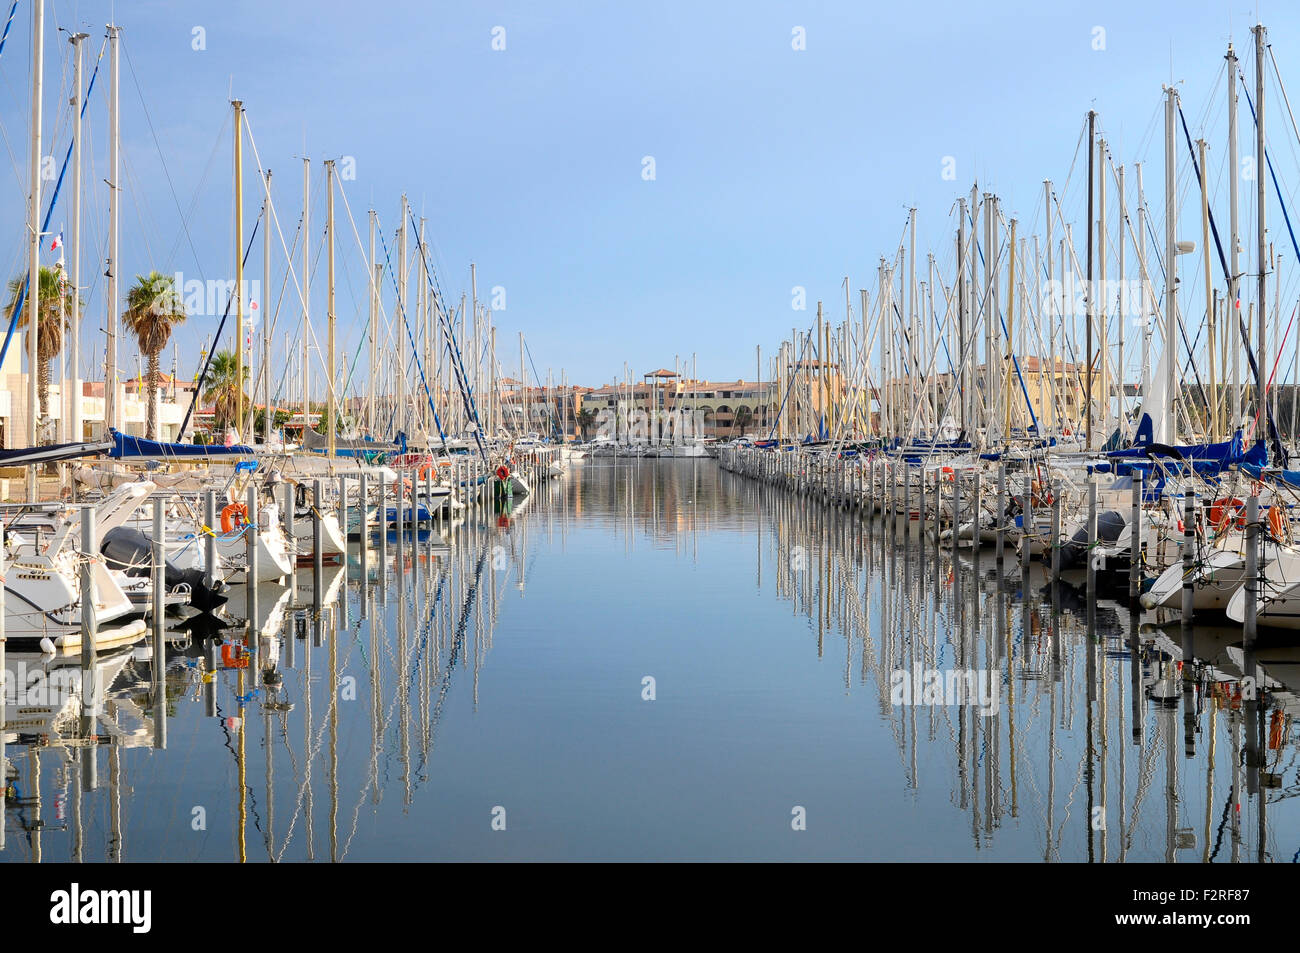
[0,0,1300,387]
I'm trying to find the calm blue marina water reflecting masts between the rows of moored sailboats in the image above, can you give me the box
[0,459,1300,863]
